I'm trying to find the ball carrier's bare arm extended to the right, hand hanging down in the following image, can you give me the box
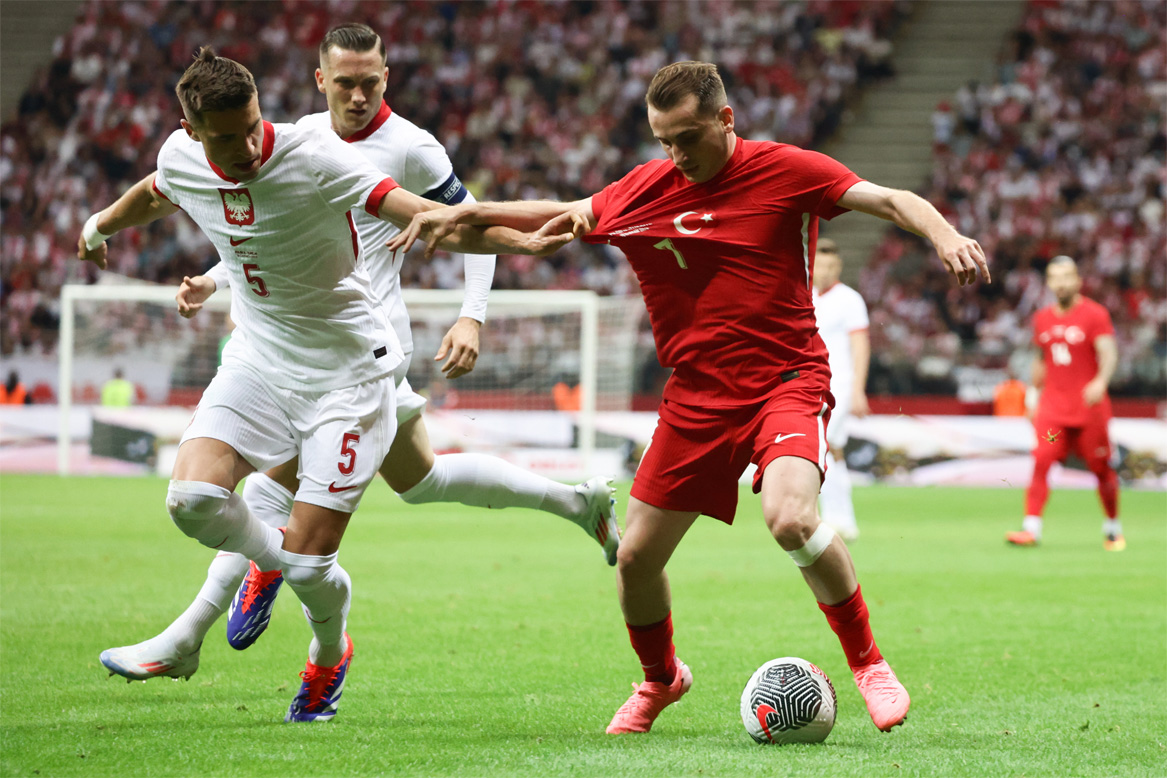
[838,181,992,286]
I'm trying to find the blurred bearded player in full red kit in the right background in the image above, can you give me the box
[1005,255,1126,551]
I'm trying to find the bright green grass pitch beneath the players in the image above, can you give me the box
[0,476,1167,778]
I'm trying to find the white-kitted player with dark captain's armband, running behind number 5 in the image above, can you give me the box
[102,23,620,680]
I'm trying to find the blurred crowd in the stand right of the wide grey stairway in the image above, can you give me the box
[859,0,1167,397]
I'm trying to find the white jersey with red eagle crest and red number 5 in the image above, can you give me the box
[154,121,404,392]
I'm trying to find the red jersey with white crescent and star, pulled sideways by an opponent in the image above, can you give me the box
[585,138,862,407]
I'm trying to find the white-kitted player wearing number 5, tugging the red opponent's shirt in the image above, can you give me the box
[77,47,571,721]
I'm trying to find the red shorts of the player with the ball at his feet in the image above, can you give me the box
[631,370,834,524]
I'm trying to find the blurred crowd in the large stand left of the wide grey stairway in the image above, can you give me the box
[0,0,906,366]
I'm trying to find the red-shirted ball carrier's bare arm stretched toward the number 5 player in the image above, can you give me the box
[387,199,594,258]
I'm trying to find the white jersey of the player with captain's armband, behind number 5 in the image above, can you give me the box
[296,101,495,362]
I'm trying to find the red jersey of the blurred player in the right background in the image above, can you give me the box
[1033,297,1114,427]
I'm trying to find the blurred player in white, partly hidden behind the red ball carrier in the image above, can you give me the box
[813,238,872,540]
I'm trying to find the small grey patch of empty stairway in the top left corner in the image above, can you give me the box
[0,0,82,121]
